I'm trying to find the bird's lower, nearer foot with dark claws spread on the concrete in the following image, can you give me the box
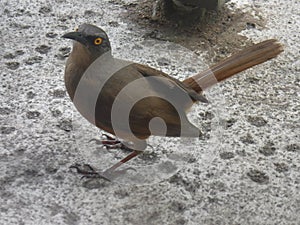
[70,163,136,181]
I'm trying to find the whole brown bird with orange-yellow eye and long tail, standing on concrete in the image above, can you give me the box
[62,23,283,180]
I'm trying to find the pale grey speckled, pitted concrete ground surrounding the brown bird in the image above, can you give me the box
[0,0,300,225]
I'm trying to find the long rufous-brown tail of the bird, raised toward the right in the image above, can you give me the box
[183,39,283,92]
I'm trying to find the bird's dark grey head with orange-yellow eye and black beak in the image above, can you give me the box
[62,23,111,58]
